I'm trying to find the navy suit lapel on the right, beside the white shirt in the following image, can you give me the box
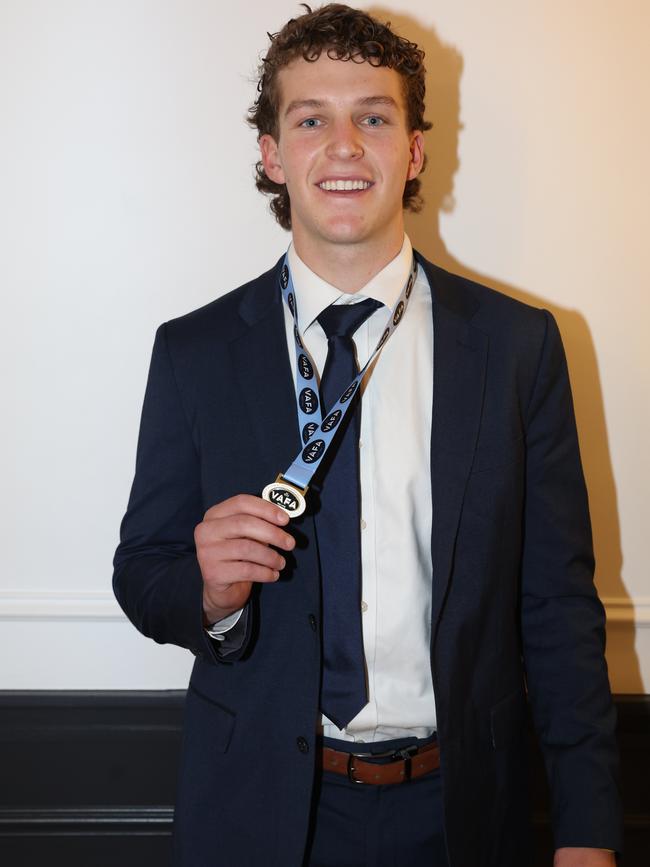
[420,258,488,636]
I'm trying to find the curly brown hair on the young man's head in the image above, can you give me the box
[247,3,431,229]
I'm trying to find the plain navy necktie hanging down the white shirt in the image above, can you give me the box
[316,299,382,729]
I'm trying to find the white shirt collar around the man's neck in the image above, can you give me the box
[288,235,413,334]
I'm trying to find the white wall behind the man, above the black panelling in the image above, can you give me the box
[0,0,650,692]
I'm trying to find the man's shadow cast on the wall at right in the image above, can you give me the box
[368,6,644,693]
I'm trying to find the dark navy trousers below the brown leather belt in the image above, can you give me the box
[304,740,448,867]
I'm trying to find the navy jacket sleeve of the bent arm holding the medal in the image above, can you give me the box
[113,325,248,662]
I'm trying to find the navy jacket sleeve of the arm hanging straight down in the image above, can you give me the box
[521,311,622,851]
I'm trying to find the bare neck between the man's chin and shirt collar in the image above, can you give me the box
[293,230,404,294]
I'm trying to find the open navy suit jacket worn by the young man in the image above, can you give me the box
[114,257,621,867]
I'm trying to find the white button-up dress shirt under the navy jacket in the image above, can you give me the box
[285,236,436,743]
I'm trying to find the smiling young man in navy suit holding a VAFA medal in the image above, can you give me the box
[114,5,620,867]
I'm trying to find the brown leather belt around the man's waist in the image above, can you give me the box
[323,741,440,786]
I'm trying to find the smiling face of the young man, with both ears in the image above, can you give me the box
[260,52,424,261]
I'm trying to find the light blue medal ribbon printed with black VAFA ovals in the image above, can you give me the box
[280,256,418,493]
